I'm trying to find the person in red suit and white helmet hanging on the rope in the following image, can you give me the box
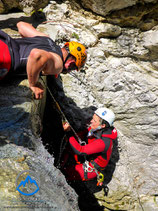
[63,108,117,181]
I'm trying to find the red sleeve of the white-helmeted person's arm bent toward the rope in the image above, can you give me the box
[69,137,105,155]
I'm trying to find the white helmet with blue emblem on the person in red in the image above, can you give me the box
[95,108,115,126]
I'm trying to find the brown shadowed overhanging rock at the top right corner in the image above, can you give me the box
[81,0,158,30]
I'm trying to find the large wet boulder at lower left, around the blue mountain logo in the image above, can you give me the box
[0,75,78,210]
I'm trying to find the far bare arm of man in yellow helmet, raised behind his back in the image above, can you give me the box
[17,21,49,37]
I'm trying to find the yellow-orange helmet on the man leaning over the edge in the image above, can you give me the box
[65,41,87,70]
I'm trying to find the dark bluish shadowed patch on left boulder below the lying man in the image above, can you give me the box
[0,76,35,149]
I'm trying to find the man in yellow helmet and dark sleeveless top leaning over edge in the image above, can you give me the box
[0,21,87,99]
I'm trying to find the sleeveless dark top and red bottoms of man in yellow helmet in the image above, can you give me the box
[0,30,63,79]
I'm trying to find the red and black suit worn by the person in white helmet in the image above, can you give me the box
[66,128,117,180]
